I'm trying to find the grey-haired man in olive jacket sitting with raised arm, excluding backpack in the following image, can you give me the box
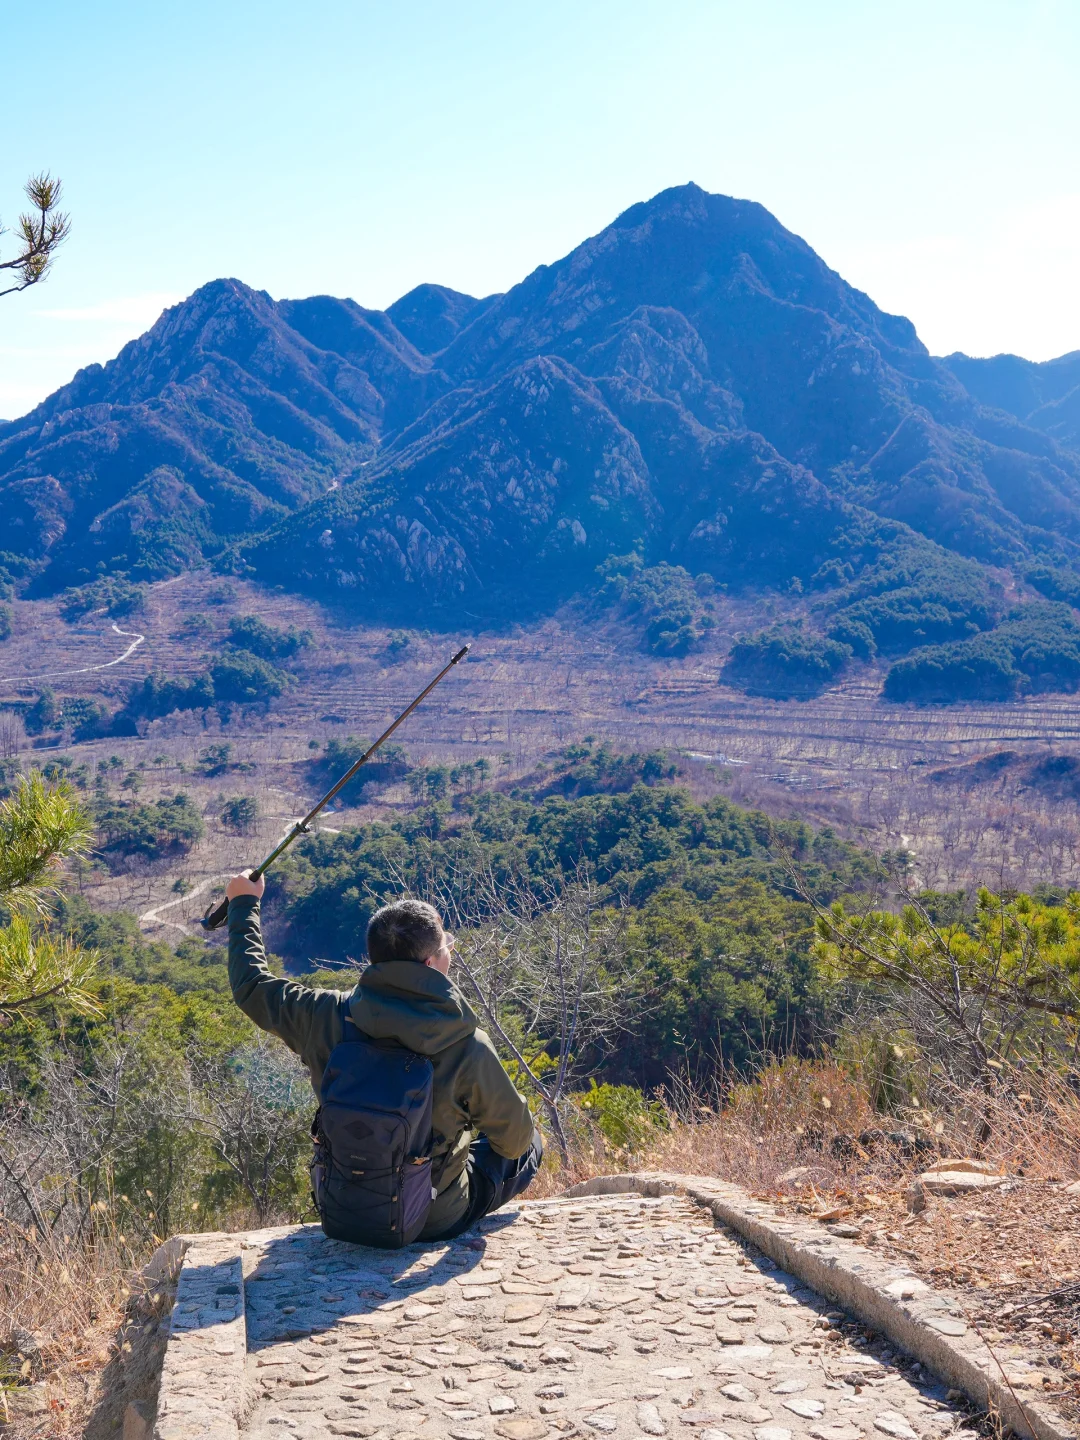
[225,876,543,1240]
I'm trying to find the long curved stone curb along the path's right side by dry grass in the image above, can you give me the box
[559,1171,1077,1440]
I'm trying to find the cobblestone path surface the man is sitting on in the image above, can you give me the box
[240,1195,962,1440]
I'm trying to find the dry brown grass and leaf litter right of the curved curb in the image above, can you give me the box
[537,1060,1080,1421]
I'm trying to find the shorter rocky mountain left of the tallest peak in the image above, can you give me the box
[0,281,394,589]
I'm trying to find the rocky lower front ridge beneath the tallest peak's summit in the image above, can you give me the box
[242,357,898,615]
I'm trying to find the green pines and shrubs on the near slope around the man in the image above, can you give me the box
[0,744,1080,1254]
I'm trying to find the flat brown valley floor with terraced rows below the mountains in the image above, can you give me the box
[0,573,1080,940]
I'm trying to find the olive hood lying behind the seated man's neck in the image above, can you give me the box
[348,960,477,1056]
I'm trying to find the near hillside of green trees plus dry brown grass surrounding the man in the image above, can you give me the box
[0,740,1080,1414]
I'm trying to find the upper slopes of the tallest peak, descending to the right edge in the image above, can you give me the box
[439,186,1080,563]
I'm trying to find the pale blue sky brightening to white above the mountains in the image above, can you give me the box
[0,0,1080,416]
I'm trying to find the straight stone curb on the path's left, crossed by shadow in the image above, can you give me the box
[151,1234,248,1440]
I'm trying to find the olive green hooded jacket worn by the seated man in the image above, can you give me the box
[229,896,533,1238]
